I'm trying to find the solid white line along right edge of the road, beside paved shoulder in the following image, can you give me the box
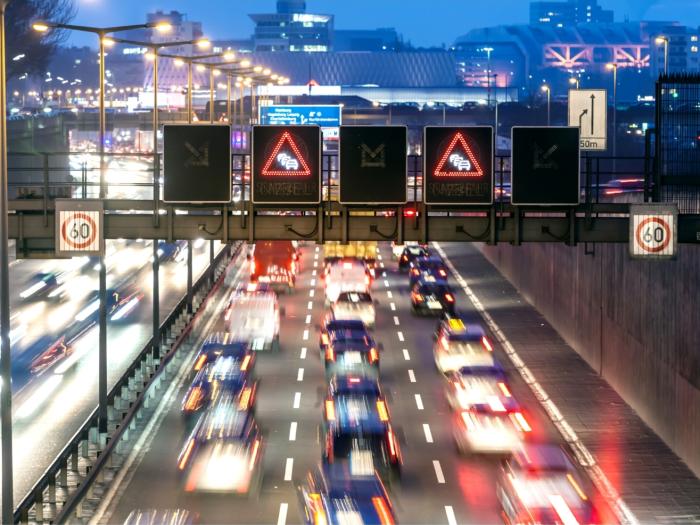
[433,242,639,524]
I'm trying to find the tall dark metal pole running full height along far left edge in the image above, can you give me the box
[0,1,14,523]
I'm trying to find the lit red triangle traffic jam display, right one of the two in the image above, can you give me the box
[423,126,493,205]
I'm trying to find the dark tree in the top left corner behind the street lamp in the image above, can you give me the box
[5,0,75,79]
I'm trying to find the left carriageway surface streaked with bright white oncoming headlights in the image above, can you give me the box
[1,241,220,503]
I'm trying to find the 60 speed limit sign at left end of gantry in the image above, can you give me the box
[56,199,104,257]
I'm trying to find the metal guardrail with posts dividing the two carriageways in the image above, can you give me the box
[14,243,242,523]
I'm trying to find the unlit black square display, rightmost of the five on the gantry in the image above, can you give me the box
[511,126,581,206]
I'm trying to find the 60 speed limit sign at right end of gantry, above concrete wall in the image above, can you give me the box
[630,204,678,259]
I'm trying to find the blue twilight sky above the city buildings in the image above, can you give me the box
[69,0,700,46]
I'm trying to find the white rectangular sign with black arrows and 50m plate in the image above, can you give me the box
[569,89,608,151]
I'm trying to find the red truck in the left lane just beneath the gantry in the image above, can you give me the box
[248,241,299,292]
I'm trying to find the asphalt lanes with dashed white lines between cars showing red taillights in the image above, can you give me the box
[95,243,614,525]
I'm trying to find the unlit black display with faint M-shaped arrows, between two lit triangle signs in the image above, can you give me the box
[339,126,408,206]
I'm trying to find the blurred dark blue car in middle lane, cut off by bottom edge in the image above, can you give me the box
[297,462,396,525]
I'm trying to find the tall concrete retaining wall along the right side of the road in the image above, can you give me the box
[481,244,700,476]
